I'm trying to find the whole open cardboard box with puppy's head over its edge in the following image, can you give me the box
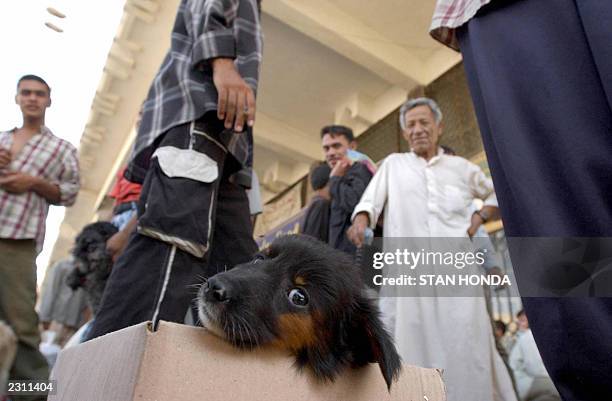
[49,322,446,401]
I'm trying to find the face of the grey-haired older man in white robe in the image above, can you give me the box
[403,105,442,157]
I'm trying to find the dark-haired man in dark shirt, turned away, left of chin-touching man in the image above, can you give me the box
[302,163,331,242]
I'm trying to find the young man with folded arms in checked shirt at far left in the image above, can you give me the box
[0,75,79,394]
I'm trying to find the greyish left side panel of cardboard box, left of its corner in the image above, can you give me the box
[48,323,147,401]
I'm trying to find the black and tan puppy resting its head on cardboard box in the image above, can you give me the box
[197,235,401,389]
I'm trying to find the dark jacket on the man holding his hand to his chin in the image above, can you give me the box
[328,163,372,255]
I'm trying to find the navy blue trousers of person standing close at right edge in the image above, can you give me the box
[457,0,612,401]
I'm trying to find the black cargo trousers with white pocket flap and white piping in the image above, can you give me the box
[89,115,257,339]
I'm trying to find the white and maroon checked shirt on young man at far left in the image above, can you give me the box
[0,127,79,251]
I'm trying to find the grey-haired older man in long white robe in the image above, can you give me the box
[348,98,516,401]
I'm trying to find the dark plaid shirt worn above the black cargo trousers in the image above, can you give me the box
[126,0,262,182]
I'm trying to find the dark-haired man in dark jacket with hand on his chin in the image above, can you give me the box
[321,125,372,255]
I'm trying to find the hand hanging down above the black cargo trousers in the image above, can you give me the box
[211,58,255,132]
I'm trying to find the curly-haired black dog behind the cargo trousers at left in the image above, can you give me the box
[66,222,118,316]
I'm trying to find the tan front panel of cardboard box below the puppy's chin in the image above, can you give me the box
[133,321,446,401]
